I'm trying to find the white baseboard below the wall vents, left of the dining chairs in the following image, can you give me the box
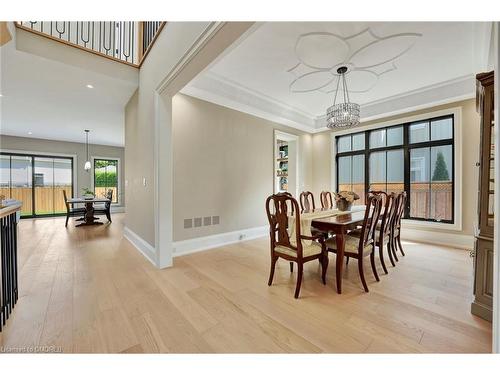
[172,225,269,257]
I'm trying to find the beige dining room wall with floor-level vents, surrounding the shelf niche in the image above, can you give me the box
[172,94,311,241]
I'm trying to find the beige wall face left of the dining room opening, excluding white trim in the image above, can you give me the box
[125,22,213,247]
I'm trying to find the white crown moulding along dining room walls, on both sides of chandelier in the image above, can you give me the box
[181,68,475,133]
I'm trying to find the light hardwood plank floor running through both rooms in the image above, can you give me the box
[3,214,491,353]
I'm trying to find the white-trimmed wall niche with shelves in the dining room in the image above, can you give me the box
[274,131,298,195]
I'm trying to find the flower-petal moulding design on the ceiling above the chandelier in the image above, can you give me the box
[287,28,422,94]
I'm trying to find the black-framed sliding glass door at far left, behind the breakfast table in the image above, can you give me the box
[0,153,73,217]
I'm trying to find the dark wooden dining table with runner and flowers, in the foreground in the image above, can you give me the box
[302,205,365,294]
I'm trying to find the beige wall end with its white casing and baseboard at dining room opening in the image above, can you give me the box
[125,22,253,267]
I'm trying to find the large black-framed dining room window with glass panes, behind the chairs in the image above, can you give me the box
[335,115,455,224]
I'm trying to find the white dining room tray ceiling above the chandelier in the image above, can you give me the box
[183,22,491,130]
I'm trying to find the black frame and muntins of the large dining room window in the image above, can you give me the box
[335,114,456,224]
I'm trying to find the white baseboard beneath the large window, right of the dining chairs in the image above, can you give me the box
[401,228,474,250]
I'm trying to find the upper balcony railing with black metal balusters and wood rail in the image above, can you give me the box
[16,21,165,67]
